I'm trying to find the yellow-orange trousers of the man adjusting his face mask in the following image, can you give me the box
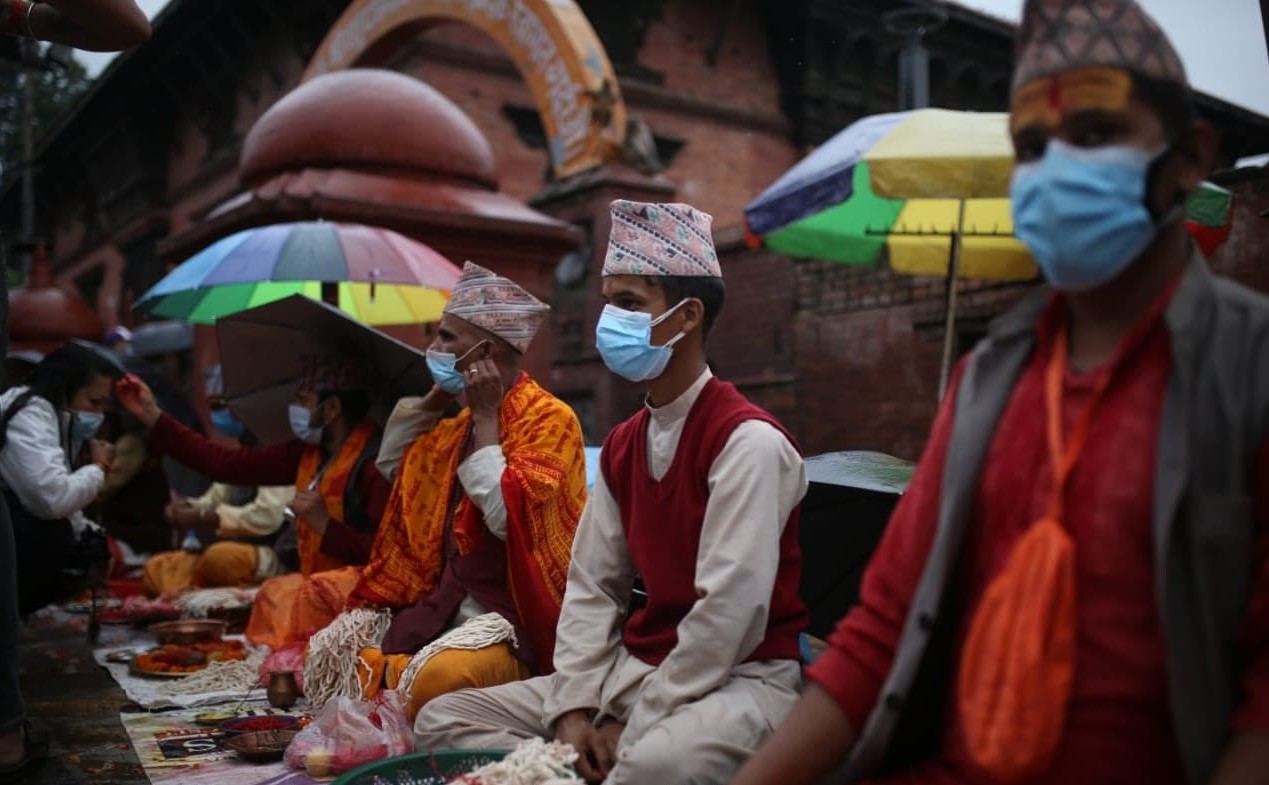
[358,643,532,724]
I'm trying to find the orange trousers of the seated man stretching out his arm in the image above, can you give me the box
[246,567,362,649]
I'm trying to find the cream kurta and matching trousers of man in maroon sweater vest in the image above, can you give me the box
[415,370,807,785]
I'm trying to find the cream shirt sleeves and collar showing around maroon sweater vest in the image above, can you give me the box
[543,369,807,738]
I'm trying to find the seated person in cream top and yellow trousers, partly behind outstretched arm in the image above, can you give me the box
[145,365,296,596]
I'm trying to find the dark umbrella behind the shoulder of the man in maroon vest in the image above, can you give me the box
[798,450,915,638]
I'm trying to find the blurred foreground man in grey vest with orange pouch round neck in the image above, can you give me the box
[733,0,1269,785]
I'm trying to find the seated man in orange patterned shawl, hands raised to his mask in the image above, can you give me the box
[305,263,586,717]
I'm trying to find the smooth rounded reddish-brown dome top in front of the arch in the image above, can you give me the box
[239,68,497,189]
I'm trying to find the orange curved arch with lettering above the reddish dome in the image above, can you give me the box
[303,0,626,178]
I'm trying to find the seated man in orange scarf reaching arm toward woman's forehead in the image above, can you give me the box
[118,354,390,648]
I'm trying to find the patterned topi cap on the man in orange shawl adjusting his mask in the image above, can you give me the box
[444,261,551,354]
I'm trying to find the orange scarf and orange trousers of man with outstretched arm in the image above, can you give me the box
[246,421,376,648]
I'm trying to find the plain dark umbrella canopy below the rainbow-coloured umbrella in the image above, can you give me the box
[216,295,431,444]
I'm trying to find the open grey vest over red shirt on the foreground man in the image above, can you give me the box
[844,250,1269,785]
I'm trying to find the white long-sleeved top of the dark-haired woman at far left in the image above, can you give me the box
[0,387,105,533]
